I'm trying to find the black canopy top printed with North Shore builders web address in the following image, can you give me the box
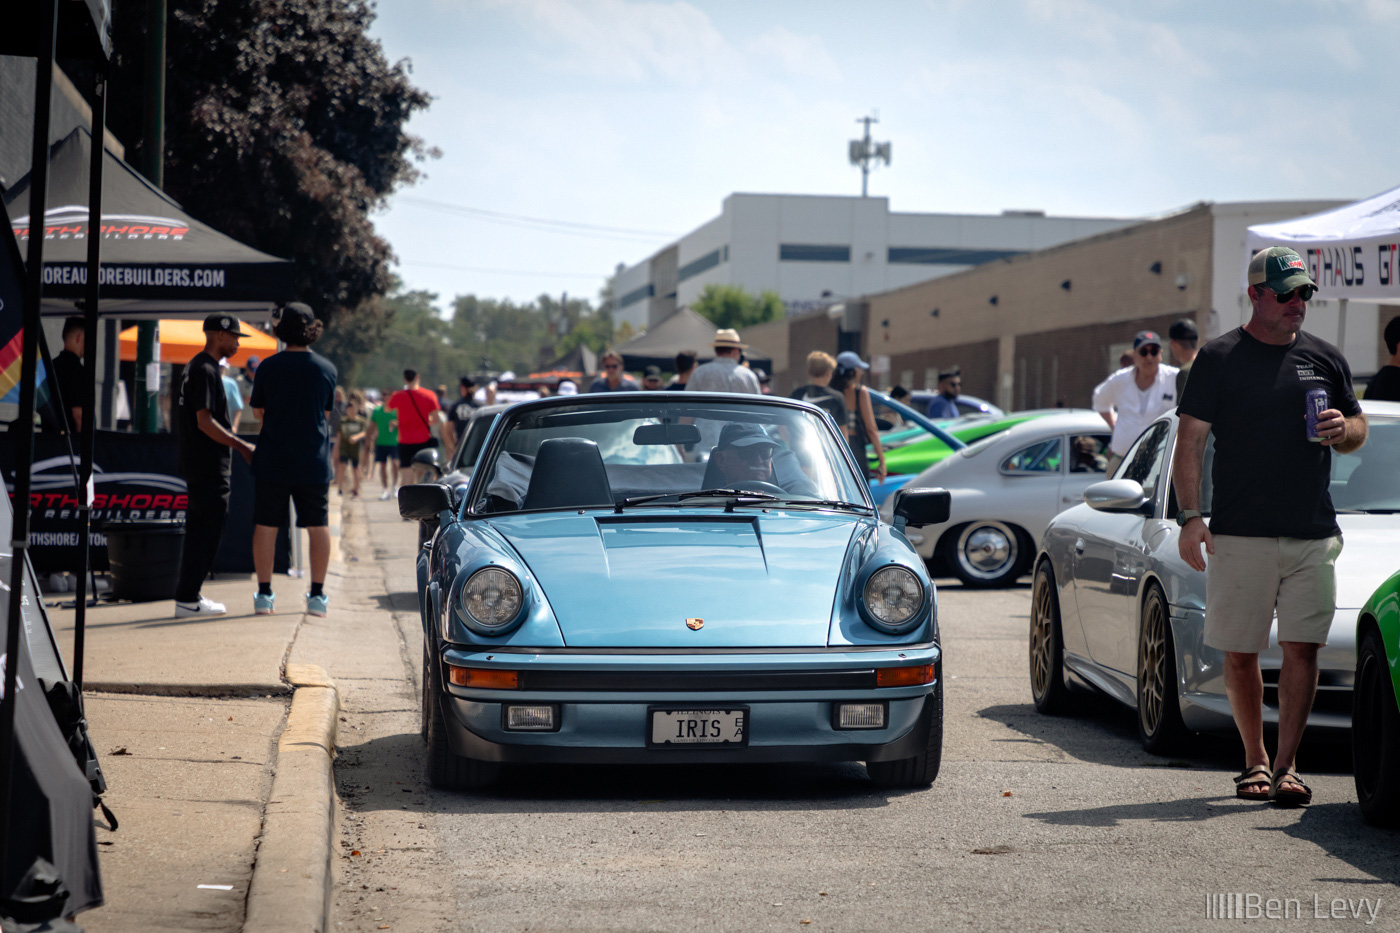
[4,127,294,319]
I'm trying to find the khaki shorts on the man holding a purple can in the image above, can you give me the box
[1205,535,1341,654]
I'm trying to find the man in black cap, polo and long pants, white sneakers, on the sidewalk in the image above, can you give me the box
[175,314,253,619]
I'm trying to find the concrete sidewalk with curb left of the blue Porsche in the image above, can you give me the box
[45,492,344,933]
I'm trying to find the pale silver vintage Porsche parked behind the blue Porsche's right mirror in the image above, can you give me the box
[881,409,1112,587]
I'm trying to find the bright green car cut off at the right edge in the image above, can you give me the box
[1351,573,1400,829]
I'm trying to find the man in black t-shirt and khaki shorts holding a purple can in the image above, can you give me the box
[1172,247,1366,806]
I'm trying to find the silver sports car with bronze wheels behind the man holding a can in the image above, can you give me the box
[1030,401,1400,752]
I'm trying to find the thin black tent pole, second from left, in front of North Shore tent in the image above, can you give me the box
[73,62,106,683]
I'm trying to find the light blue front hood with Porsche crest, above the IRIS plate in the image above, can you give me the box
[493,510,874,649]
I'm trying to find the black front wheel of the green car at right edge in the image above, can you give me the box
[1351,626,1400,829]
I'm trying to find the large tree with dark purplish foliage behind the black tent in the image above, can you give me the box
[108,0,434,337]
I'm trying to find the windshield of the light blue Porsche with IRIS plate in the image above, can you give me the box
[470,396,865,513]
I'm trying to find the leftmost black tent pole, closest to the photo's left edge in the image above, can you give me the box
[0,0,59,880]
